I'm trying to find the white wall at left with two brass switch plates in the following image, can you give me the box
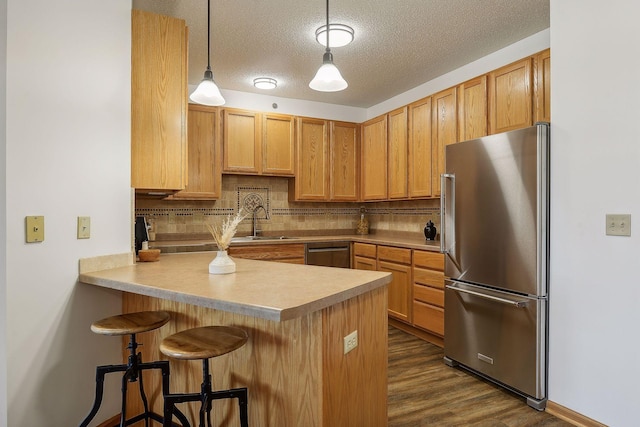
[0,0,131,427]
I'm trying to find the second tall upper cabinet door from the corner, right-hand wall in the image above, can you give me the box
[387,107,409,199]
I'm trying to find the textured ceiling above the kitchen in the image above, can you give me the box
[133,0,549,108]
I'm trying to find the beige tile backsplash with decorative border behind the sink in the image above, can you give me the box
[135,175,440,240]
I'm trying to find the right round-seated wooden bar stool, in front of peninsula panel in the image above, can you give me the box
[160,326,249,427]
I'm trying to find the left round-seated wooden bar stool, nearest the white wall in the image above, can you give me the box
[80,311,188,427]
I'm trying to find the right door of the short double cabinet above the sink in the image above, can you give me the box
[262,114,294,176]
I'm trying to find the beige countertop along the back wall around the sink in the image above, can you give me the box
[149,231,440,252]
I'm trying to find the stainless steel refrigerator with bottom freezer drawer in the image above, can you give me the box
[441,123,550,410]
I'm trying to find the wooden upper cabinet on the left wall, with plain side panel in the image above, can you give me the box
[131,9,188,191]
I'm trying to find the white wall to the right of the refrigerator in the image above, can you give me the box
[549,0,640,426]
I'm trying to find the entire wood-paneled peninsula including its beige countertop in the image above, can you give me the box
[79,252,391,427]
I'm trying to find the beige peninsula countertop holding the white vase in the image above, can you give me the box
[78,252,391,321]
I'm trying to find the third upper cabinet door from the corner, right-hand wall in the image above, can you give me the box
[407,97,433,197]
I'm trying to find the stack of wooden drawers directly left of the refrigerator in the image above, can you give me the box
[413,250,444,337]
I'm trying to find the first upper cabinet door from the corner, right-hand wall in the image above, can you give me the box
[360,114,387,200]
